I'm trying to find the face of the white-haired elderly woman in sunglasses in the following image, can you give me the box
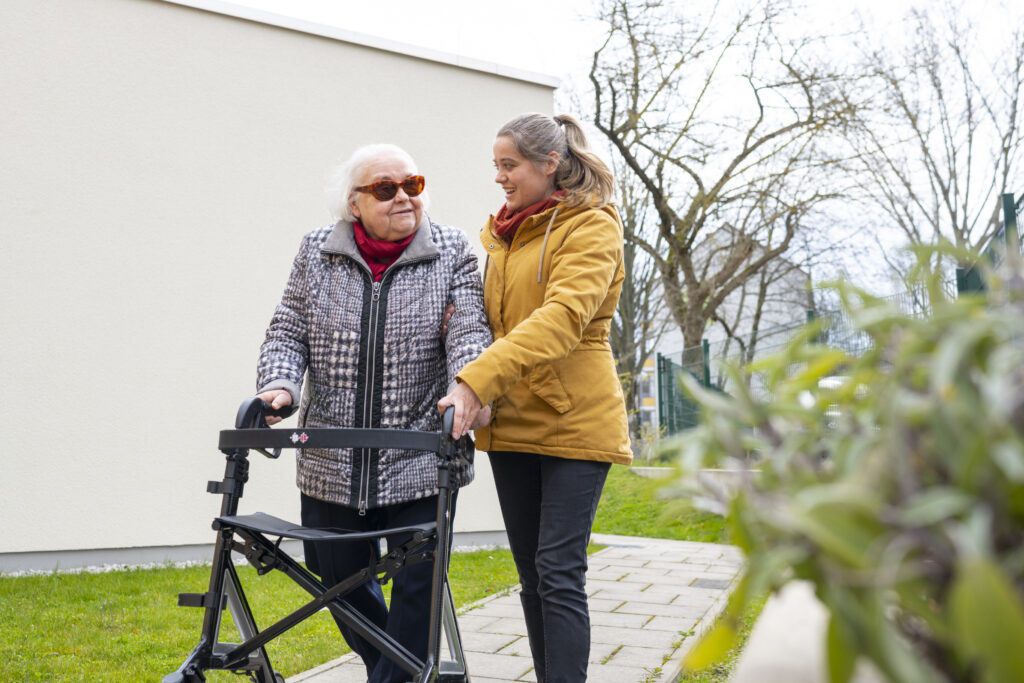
[349,154,423,242]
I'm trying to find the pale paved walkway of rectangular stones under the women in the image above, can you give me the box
[288,535,741,683]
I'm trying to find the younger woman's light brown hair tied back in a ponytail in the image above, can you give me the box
[498,114,615,207]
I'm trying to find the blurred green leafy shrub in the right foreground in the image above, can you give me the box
[676,249,1024,683]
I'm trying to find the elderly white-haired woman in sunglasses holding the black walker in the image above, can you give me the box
[258,144,492,683]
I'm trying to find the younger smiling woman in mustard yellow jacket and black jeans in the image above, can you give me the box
[438,114,632,683]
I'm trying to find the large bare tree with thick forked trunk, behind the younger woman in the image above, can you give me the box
[590,0,856,347]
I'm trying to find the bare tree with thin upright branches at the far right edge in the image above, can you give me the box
[852,3,1024,270]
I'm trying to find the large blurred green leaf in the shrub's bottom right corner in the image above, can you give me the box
[949,557,1024,683]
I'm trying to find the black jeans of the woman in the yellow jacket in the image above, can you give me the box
[487,452,610,683]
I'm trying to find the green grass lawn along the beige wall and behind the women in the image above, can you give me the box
[0,466,737,683]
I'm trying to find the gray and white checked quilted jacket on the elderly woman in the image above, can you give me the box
[257,215,492,510]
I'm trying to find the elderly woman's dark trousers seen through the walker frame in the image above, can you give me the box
[301,494,456,683]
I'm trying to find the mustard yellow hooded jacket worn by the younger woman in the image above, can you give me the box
[458,200,633,464]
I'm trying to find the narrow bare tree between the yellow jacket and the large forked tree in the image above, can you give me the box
[610,167,670,444]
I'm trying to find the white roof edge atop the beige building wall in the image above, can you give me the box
[163,0,560,88]
